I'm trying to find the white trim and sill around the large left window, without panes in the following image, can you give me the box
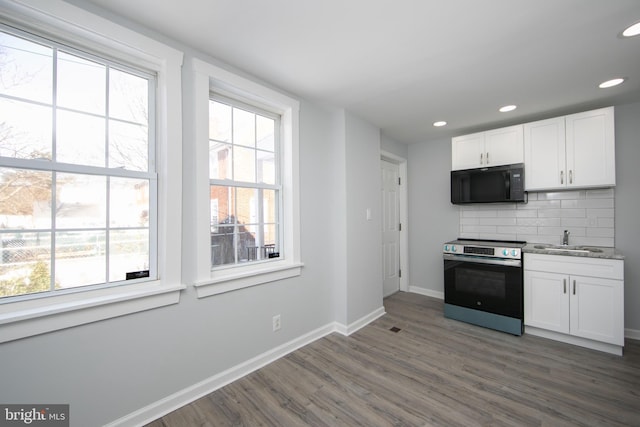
[0,0,186,343]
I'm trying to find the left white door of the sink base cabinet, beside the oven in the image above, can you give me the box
[524,270,569,334]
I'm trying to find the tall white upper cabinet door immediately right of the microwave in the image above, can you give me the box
[524,117,567,191]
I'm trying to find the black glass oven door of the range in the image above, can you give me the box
[444,254,524,319]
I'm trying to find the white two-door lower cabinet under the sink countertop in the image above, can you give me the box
[524,253,624,354]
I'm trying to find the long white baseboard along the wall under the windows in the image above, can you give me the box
[106,307,386,427]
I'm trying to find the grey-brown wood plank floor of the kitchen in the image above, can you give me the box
[148,292,640,427]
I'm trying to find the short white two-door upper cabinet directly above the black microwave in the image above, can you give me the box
[451,125,524,170]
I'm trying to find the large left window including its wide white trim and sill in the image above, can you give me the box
[0,0,185,342]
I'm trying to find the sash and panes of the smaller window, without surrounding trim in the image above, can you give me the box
[209,97,281,268]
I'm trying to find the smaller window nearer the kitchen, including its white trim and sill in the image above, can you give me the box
[188,59,303,298]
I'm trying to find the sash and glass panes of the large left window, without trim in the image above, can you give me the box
[0,27,157,298]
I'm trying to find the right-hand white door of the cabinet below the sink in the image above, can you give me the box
[570,276,624,345]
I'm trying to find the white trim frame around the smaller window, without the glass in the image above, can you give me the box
[188,58,304,298]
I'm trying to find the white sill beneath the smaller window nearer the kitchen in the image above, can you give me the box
[193,262,304,298]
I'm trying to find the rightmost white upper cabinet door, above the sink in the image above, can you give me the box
[565,107,616,187]
